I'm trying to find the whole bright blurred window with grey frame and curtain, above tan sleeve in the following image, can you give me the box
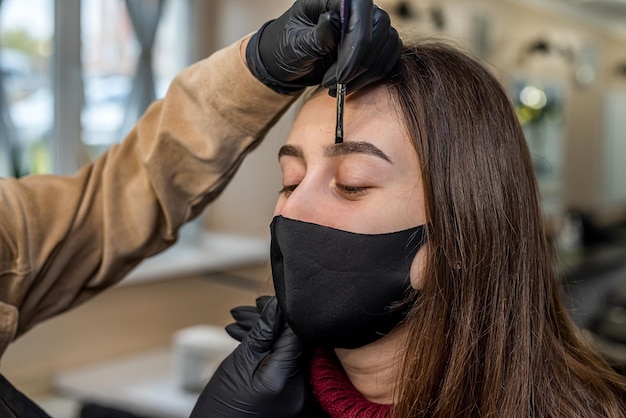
[0,0,191,177]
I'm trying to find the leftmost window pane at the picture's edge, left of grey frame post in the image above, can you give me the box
[0,0,54,177]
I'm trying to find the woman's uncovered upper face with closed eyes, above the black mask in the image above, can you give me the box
[274,86,426,286]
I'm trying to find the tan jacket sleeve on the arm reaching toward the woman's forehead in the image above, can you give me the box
[0,38,294,354]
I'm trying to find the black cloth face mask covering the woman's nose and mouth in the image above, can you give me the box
[271,216,424,348]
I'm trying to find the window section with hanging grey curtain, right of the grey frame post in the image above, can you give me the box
[81,0,189,159]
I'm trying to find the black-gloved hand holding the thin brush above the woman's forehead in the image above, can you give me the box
[246,0,402,94]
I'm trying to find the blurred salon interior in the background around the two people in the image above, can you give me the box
[0,0,626,418]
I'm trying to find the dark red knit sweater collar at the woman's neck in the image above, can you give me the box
[311,348,391,418]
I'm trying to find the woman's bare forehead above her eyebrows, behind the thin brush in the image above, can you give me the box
[287,86,415,155]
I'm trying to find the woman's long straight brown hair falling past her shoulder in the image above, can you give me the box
[387,41,626,418]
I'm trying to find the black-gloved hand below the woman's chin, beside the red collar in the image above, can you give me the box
[191,297,312,418]
